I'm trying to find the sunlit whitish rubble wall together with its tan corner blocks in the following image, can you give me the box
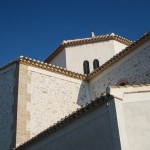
[18,65,90,139]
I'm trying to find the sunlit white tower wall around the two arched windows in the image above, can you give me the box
[66,40,126,74]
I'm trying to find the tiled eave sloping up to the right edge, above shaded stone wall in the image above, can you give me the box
[85,32,150,81]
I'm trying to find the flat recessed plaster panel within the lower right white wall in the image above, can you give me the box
[123,92,150,150]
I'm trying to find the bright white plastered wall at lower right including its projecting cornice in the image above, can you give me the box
[111,85,150,150]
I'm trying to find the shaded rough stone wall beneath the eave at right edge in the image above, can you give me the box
[90,42,150,98]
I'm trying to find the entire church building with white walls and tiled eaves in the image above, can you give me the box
[0,33,150,150]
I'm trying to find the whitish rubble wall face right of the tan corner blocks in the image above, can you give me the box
[27,67,90,137]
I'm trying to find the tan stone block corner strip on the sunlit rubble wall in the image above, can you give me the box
[16,64,31,145]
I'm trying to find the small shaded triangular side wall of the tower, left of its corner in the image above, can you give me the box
[50,48,66,68]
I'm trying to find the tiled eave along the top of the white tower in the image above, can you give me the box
[44,33,132,63]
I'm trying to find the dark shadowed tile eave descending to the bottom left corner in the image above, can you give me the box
[14,94,114,150]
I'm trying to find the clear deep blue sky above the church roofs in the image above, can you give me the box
[0,0,150,66]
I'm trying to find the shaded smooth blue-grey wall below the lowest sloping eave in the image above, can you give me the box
[22,100,121,150]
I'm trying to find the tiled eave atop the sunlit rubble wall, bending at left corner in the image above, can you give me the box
[0,56,86,80]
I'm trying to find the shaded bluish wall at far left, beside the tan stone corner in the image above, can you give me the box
[0,65,16,150]
